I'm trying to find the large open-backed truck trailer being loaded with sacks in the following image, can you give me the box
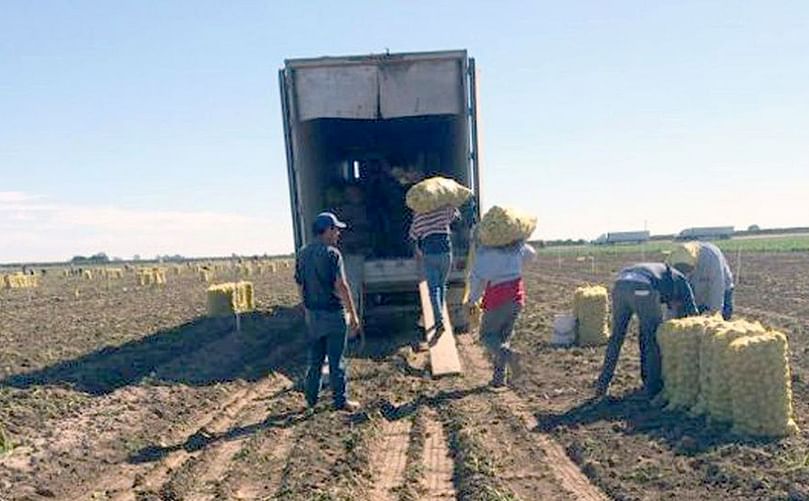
[279,50,480,327]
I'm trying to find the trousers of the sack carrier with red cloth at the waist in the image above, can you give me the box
[480,301,522,386]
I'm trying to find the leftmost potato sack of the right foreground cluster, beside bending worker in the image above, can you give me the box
[657,317,707,410]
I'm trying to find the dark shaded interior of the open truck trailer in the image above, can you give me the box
[297,115,474,259]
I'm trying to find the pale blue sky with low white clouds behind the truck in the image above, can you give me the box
[0,0,809,261]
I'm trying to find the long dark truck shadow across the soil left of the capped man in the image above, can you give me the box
[0,307,305,395]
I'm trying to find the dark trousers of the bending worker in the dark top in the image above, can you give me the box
[598,280,663,397]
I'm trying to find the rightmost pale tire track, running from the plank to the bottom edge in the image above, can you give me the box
[458,335,609,501]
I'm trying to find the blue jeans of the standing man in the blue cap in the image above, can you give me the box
[304,310,348,407]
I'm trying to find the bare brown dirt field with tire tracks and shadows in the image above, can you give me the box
[0,253,809,500]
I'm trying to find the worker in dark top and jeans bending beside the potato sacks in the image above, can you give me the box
[596,263,698,398]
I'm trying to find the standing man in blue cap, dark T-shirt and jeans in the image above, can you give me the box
[295,212,360,411]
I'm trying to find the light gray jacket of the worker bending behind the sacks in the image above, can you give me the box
[688,242,733,313]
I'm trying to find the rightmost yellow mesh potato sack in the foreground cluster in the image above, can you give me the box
[728,332,798,437]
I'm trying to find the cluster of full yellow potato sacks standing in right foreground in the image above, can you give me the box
[657,317,798,437]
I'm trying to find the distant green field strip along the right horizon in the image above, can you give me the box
[540,235,809,256]
